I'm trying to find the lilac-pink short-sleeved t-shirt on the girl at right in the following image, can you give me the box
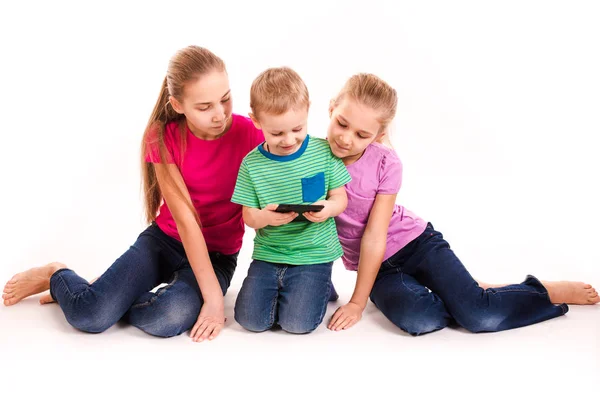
[335,143,427,271]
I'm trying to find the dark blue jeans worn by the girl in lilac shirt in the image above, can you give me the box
[371,224,569,336]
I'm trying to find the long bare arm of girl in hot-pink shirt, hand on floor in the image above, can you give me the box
[154,164,225,341]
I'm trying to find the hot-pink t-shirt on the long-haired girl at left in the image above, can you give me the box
[146,114,264,254]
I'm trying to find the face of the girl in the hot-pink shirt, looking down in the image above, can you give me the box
[171,71,232,139]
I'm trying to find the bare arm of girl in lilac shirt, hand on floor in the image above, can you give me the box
[327,194,396,331]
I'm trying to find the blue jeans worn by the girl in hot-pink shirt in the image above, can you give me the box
[50,224,237,337]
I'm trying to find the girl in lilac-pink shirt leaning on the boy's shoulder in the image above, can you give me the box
[328,74,600,335]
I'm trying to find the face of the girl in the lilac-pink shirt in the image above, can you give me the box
[327,96,383,165]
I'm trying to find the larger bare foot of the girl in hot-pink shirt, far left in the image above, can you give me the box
[2,262,66,306]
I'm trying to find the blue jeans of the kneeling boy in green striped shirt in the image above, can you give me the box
[235,260,333,333]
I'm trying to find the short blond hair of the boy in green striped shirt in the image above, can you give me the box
[250,67,310,118]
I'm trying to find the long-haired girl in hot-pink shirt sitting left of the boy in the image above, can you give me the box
[2,46,264,341]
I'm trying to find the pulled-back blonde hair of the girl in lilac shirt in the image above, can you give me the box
[334,73,398,132]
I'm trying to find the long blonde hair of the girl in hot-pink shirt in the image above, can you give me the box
[141,46,225,222]
